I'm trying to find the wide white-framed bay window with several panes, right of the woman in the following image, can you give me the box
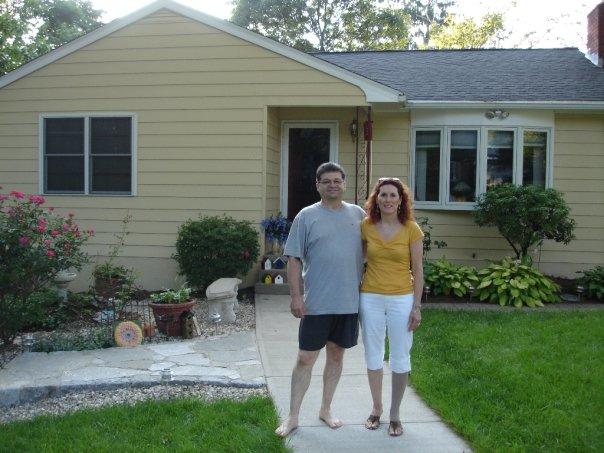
[410,125,552,210]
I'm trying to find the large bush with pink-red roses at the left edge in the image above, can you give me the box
[0,187,94,344]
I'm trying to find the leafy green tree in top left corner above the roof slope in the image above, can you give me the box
[0,0,102,75]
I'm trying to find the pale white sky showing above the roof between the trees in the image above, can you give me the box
[92,0,601,52]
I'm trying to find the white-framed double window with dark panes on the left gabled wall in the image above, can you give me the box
[40,113,136,195]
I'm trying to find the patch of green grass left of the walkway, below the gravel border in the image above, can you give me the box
[0,397,287,452]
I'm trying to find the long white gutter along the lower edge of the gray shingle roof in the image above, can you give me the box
[407,101,604,110]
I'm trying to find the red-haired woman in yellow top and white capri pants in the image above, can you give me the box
[359,178,424,436]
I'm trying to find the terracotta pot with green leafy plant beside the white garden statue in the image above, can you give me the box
[149,287,197,337]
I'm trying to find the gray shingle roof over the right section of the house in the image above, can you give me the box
[314,48,604,102]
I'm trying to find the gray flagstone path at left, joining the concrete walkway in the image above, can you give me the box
[0,332,265,407]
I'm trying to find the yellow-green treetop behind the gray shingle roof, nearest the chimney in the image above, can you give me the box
[428,13,509,49]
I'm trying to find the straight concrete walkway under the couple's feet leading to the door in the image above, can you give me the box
[256,295,471,453]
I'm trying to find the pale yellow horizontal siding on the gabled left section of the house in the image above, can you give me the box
[0,10,366,289]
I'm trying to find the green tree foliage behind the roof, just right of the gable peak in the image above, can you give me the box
[231,0,410,51]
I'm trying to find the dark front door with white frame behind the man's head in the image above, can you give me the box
[281,122,337,220]
